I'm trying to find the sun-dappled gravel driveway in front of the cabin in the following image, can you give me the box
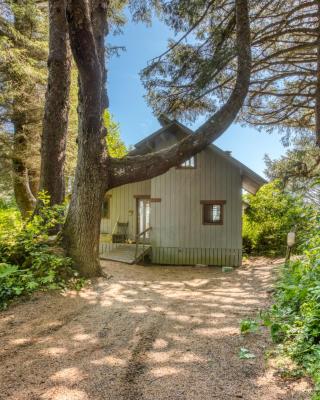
[0,259,311,400]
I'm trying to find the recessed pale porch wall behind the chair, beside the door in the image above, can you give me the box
[101,180,151,239]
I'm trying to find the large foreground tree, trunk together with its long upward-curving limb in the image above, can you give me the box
[63,0,251,276]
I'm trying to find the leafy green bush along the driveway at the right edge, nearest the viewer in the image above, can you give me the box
[265,218,320,399]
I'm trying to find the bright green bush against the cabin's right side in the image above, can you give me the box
[243,181,314,256]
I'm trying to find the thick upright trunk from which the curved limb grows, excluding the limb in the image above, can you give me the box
[63,0,107,276]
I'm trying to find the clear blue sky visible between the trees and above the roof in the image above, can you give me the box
[108,13,285,176]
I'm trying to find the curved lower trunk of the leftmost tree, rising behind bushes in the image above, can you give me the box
[12,121,36,219]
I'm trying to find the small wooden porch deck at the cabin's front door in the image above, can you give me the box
[100,244,151,264]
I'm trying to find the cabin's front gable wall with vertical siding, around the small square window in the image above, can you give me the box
[151,148,242,265]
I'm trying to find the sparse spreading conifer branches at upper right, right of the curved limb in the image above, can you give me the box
[242,0,320,144]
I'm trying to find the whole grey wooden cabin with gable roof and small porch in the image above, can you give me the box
[100,120,266,266]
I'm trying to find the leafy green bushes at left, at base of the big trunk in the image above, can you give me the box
[0,193,82,308]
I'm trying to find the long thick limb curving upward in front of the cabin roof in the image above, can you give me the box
[108,0,251,188]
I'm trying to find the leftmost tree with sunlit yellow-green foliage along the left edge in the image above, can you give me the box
[0,0,47,217]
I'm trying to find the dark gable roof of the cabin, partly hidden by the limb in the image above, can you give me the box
[130,118,267,193]
